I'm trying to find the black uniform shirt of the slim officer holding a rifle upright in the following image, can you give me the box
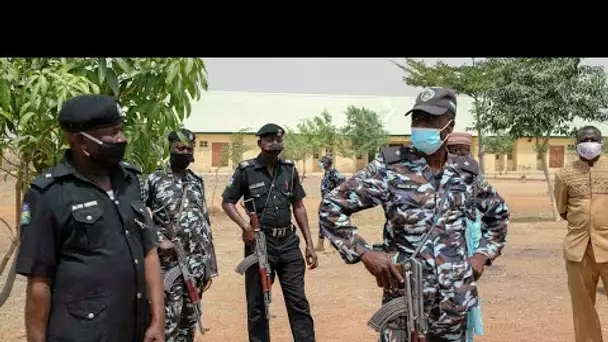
[222,154,306,228]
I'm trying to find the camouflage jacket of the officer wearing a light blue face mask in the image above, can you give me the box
[319,147,509,335]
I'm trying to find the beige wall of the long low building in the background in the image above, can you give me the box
[194,134,576,174]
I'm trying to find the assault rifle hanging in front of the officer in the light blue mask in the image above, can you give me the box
[367,258,428,342]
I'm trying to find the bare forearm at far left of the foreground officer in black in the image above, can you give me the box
[25,277,51,342]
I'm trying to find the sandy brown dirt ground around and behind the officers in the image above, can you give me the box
[0,175,608,342]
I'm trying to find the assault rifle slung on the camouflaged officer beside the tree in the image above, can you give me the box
[152,187,205,334]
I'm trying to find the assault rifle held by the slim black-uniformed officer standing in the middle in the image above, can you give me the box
[235,198,272,319]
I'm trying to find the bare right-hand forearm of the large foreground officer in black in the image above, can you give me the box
[145,248,165,324]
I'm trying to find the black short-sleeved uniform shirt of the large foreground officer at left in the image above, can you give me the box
[17,151,156,342]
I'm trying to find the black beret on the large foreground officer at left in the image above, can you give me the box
[59,94,125,132]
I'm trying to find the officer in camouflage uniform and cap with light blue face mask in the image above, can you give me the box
[319,88,509,342]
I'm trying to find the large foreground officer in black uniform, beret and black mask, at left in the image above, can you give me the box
[17,95,164,342]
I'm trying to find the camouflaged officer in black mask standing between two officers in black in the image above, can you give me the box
[144,129,217,342]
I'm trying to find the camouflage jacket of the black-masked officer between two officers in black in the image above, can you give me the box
[142,166,218,279]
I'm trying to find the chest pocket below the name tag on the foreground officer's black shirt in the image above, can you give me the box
[72,207,107,250]
